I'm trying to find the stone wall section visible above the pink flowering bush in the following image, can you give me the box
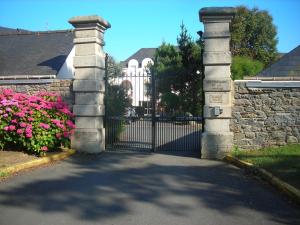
[0,79,74,107]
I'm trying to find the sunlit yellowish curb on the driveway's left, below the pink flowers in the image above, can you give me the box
[0,149,76,177]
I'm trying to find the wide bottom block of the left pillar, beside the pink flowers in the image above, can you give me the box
[71,128,105,153]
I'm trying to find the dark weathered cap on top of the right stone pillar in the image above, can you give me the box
[199,7,236,22]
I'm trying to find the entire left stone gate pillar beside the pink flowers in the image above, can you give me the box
[69,16,110,153]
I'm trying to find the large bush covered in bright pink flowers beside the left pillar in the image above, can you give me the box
[0,89,75,154]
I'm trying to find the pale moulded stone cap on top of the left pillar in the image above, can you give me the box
[69,15,111,29]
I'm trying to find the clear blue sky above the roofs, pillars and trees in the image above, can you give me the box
[0,0,300,60]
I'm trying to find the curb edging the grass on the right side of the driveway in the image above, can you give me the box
[223,155,300,204]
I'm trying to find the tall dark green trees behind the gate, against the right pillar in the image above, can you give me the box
[152,24,202,115]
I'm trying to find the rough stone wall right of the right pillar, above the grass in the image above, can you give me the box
[231,81,300,149]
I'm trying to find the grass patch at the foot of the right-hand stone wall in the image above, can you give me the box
[232,144,300,189]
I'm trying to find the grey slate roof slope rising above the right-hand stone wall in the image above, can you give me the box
[257,45,300,77]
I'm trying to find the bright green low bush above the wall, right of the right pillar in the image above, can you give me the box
[231,56,264,80]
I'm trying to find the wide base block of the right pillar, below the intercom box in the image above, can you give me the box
[201,132,233,159]
